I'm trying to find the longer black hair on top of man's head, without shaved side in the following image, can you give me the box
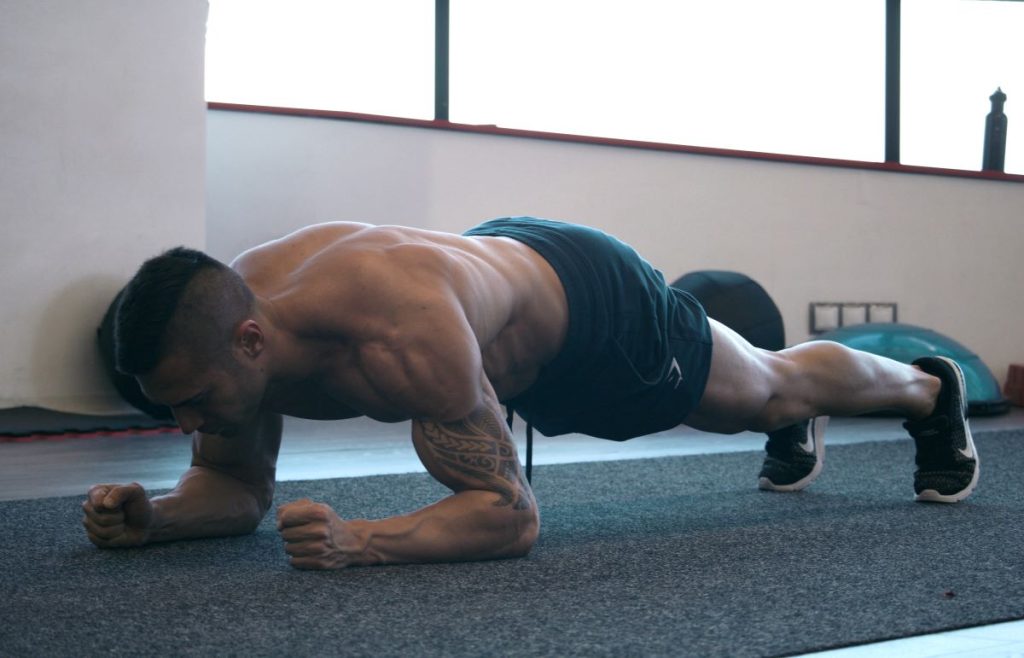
[114,247,252,375]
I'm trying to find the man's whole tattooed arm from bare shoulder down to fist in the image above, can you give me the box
[278,270,540,569]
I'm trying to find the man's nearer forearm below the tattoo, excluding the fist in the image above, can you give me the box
[350,490,540,565]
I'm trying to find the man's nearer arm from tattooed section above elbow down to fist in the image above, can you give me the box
[279,397,540,569]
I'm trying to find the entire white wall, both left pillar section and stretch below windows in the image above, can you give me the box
[8,0,1011,417]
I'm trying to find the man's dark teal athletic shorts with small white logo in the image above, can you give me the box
[465,217,712,441]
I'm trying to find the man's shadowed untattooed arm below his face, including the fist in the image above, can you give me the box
[82,414,282,547]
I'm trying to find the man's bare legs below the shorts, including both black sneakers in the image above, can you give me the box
[685,320,978,502]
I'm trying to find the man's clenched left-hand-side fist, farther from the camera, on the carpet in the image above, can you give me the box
[82,482,153,549]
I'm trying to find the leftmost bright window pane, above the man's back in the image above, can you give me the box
[206,0,434,119]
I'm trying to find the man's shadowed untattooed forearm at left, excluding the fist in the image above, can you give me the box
[146,466,270,542]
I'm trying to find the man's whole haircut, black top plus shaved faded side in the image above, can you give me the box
[114,247,253,375]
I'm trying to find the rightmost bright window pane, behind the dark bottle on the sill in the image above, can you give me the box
[900,0,1024,174]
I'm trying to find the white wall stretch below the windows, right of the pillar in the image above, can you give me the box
[207,112,1024,383]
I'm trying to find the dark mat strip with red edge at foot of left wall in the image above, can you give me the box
[0,406,177,440]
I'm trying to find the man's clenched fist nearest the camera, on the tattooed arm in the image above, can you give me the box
[278,498,366,569]
